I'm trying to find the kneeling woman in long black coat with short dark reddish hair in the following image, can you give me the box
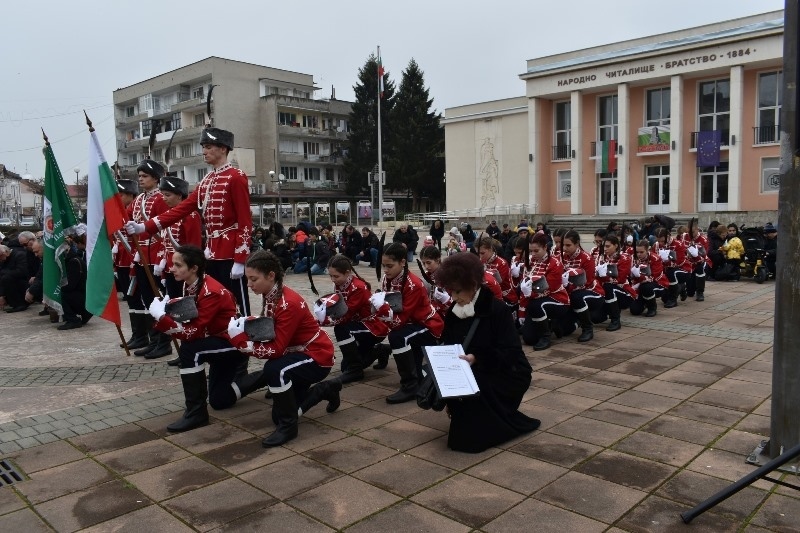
[436,254,540,453]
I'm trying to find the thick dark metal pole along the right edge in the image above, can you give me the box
[769,0,800,458]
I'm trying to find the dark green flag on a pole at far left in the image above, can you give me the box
[42,138,78,314]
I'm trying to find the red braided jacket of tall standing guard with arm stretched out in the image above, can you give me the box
[145,163,253,263]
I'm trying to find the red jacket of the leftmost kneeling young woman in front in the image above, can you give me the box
[154,275,236,341]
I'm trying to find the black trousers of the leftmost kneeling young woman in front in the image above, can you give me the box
[178,337,248,409]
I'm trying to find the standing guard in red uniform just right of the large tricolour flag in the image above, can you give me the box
[128,159,172,359]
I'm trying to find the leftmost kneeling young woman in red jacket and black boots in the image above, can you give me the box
[145,245,255,432]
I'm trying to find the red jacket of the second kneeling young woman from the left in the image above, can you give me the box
[232,285,334,368]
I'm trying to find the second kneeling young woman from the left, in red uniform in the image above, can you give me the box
[228,250,341,448]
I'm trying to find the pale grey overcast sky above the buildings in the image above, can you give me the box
[0,0,784,182]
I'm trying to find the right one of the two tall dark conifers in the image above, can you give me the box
[387,58,445,211]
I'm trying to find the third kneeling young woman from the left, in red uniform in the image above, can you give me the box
[314,254,391,384]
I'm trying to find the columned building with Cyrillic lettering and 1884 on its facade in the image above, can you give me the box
[443,11,783,220]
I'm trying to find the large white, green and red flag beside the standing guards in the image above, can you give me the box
[86,128,125,326]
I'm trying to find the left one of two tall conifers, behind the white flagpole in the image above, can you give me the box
[344,54,394,196]
